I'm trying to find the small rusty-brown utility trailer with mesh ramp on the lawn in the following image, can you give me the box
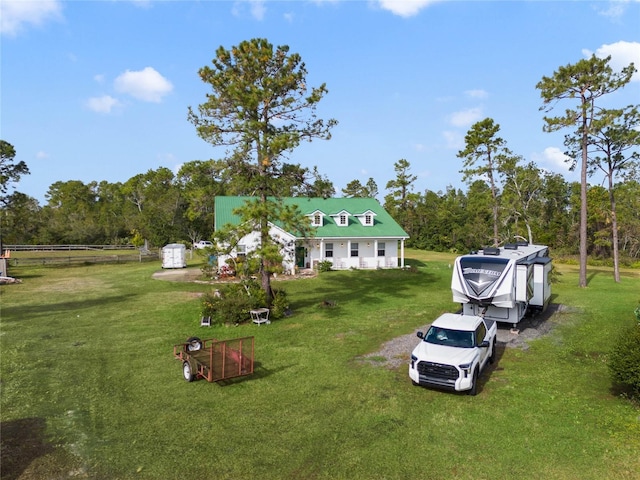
[173,337,254,382]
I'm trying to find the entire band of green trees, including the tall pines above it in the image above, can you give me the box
[0,39,640,289]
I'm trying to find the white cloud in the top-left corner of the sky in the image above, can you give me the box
[0,0,62,37]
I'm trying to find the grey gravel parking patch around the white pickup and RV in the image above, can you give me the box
[362,304,567,368]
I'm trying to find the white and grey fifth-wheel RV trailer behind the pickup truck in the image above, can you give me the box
[451,242,552,327]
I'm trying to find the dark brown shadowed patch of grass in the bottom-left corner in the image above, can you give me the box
[0,418,54,480]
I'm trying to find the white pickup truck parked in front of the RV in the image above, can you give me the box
[409,313,498,395]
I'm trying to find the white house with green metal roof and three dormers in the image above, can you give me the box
[215,197,409,274]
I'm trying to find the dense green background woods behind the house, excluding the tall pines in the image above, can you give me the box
[1,145,640,260]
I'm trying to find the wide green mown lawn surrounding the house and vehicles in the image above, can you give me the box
[0,250,640,480]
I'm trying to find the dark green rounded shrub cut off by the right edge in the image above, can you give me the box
[609,307,640,400]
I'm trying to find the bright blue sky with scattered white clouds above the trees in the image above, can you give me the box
[0,0,640,204]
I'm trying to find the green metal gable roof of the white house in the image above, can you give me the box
[215,197,409,239]
